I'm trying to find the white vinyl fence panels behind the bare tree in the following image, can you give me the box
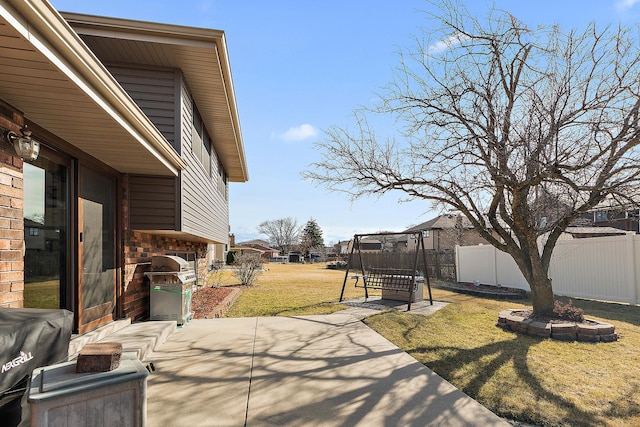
[456,234,640,305]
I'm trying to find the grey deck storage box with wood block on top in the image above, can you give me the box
[27,356,149,427]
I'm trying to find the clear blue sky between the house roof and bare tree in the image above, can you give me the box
[52,0,640,243]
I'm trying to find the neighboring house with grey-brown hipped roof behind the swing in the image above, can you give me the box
[403,213,487,251]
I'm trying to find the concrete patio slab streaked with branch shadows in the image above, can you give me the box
[147,307,509,427]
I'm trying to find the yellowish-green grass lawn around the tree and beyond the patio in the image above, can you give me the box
[221,264,640,426]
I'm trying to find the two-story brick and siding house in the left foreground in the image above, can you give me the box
[0,0,248,333]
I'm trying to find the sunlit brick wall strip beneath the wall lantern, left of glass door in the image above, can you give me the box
[0,111,24,308]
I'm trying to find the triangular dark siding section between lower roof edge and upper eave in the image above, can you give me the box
[109,66,180,152]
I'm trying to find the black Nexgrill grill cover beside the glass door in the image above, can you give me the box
[0,308,73,425]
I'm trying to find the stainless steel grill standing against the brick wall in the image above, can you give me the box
[145,255,196,325]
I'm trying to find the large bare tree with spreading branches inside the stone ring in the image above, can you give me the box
[305,1,640,315]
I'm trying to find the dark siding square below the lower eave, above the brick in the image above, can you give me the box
[129,175,178,230]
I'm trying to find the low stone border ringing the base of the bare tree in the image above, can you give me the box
[497,309,618,342]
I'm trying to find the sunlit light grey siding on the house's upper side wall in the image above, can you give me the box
[181,84,229,243]
